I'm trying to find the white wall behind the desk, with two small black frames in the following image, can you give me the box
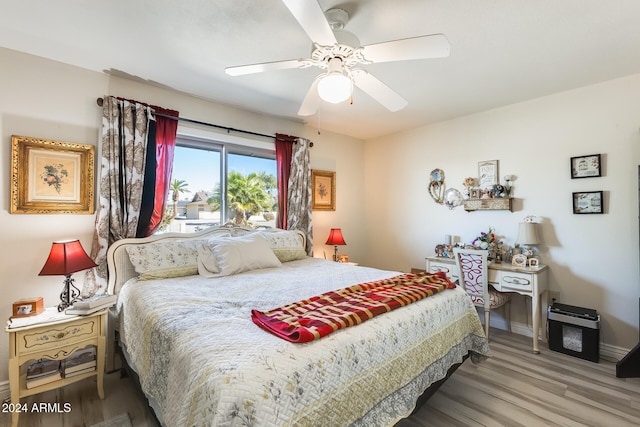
[365,75,640,354]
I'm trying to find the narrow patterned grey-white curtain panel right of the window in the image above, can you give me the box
[287,138,313,255]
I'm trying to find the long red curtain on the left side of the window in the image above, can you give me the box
[146,106,179,236]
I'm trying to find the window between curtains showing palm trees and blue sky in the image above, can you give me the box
[159,135,277,233]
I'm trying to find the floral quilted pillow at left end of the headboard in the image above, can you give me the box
[126,241,198,280]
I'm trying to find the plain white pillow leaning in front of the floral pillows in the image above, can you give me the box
[201,233,282,276]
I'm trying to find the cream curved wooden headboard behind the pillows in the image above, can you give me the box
[107,226,306,294]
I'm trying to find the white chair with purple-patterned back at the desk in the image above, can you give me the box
[453,248,511,339]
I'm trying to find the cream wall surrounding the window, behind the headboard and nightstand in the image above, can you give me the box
[0,48,366,386]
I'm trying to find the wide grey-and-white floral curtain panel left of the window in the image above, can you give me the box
[82,96,154,295]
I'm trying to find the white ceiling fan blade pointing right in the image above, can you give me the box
[362,34,451,62]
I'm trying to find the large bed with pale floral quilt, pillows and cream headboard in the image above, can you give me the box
[107,227,490,426]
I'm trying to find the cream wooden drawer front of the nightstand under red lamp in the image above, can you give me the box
[16,317,100,354]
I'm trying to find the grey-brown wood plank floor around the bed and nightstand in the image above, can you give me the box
[5,330,640,427]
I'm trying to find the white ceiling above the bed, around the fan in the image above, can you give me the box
[0,0,640,139]
